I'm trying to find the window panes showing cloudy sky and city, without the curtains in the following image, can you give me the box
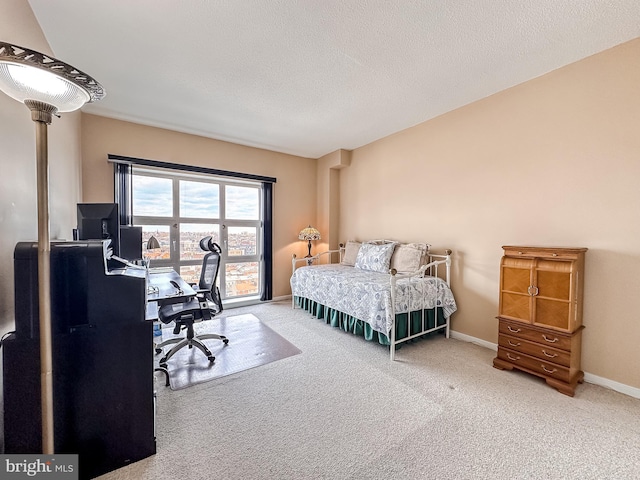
[133,174,261,299]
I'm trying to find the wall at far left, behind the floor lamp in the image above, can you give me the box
[0,0,81,333]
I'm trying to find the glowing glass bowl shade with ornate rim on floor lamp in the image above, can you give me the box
[0,42,105,112]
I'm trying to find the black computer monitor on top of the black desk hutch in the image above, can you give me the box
[78,203,120,255]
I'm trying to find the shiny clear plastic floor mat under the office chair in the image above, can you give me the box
[154,313,300,390]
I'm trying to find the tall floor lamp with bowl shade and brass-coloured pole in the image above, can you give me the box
[0,41,105,454]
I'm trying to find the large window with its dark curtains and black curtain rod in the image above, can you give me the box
[108,154,276,300]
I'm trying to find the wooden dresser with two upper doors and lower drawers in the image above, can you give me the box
[493,246,587,396]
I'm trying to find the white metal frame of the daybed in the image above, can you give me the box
[291,244,452,360]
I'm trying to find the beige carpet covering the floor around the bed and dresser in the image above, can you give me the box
[101,301,640,480]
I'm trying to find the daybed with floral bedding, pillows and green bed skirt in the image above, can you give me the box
[291,240,457,360]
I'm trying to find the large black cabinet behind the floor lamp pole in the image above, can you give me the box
[2,242,156,478]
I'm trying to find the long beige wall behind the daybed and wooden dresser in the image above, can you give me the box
[340,39,640,388]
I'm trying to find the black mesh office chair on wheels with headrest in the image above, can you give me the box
[156,236,229,373]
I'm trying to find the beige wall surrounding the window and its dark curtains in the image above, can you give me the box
[82,114,316,297]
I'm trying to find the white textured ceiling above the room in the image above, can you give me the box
[26,0,640,158]
